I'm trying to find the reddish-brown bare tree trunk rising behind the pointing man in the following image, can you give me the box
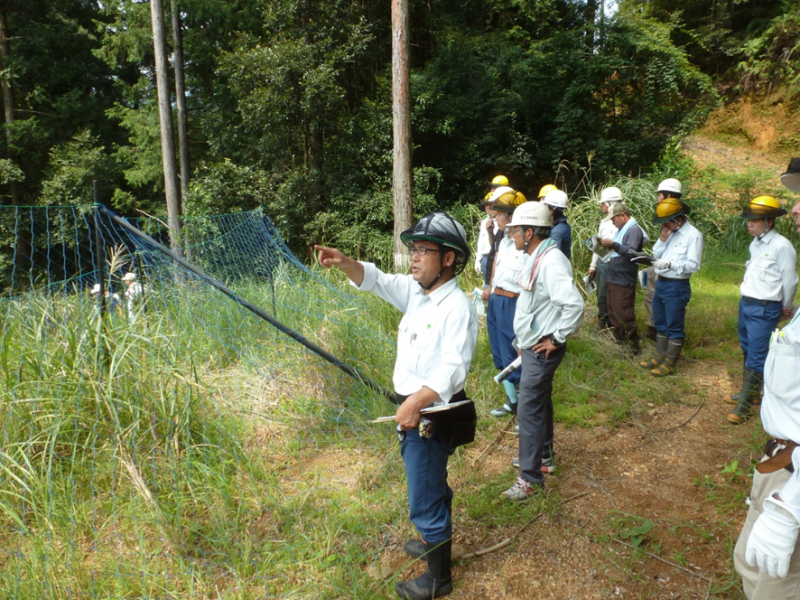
[392,0,413,271]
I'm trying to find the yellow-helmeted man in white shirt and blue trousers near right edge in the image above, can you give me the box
[727,196,797,425]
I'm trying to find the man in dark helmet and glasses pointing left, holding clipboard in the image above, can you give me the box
[316,212,478,600]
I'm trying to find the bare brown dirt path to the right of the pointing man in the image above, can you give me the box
[382,362,758,600]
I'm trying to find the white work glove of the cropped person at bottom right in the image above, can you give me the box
[745,492,800,577]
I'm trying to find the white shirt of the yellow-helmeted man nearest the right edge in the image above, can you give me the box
[739,229,797,308]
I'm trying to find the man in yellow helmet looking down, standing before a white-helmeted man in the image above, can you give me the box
[639,198,703,377]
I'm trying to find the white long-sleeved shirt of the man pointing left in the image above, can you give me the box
[351,262,478,404]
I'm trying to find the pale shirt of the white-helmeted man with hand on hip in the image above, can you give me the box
[514,249,583,349]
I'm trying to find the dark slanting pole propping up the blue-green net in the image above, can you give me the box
[99,206,397,404]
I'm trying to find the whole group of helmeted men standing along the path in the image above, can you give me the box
[316,159,800,600]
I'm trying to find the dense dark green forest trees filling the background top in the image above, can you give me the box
[0,0,800,251]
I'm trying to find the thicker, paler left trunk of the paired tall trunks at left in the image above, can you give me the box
[150,0,181,252]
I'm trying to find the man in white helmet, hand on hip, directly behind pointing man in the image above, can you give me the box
[502,202,583,502]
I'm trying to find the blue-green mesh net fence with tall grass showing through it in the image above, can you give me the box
[0,207,400,598]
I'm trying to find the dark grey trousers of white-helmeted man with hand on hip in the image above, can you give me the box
[517,343,567,484]
